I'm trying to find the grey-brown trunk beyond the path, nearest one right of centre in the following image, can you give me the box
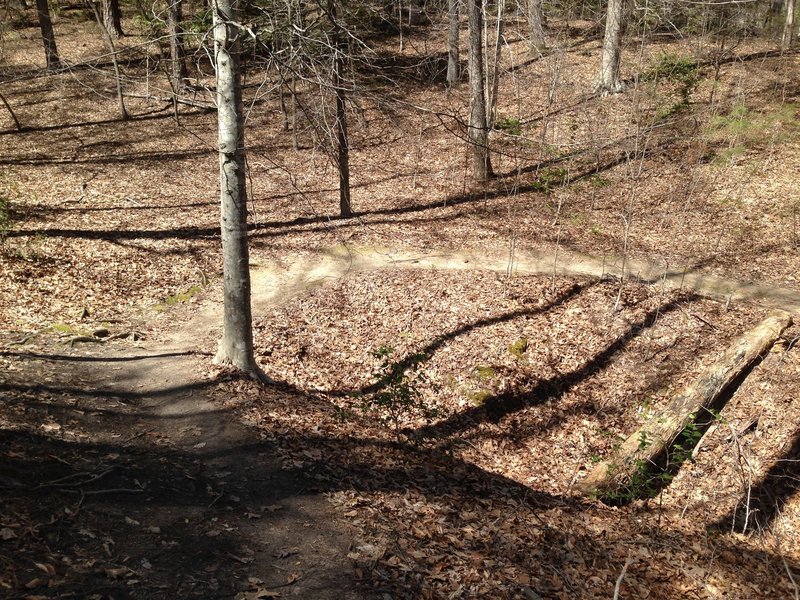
[466,0,492,181]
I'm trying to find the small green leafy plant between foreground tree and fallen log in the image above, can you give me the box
[362,346,438,431]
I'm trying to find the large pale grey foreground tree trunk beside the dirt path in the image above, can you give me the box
[213,0,263,377]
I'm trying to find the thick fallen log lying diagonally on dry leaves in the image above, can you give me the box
[578,311,792,499]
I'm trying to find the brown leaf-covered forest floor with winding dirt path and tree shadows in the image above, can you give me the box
[0,10,800,599]
